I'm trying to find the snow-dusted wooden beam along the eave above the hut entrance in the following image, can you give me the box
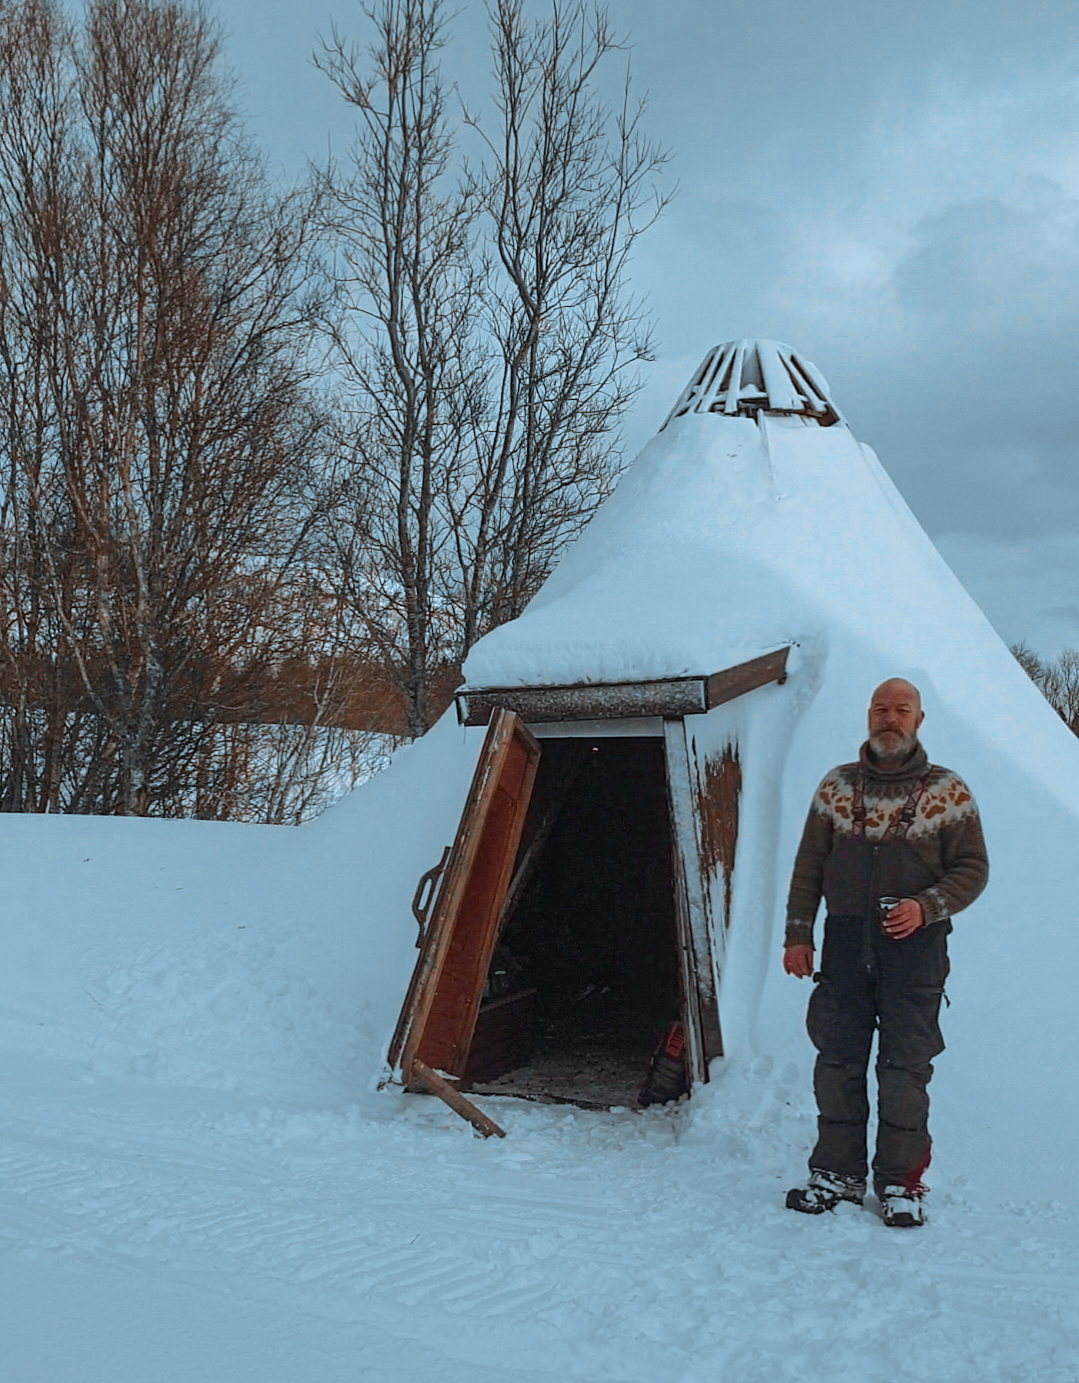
[457,647,790,725]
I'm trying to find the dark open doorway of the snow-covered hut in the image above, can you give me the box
[466,737,682,1108]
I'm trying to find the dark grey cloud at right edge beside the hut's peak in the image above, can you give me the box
[818,178,1079,537]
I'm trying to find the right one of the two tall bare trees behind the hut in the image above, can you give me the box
[451,0,675,644]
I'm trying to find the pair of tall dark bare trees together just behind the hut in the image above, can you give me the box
[317,0,665,734]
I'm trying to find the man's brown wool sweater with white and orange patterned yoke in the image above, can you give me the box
[784,744,989,946]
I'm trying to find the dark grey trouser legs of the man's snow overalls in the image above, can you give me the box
[806,916,952,1195]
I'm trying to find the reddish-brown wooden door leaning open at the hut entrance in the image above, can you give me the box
[389,709,540,1086]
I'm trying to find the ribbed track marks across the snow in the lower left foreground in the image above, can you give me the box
[0,1100,618,1338]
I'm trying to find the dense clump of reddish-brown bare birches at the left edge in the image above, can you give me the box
[0,0,367,816]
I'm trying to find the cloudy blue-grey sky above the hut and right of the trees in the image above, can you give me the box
[216,0,1079,656]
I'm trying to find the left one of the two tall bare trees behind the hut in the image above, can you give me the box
[317,0,479,734]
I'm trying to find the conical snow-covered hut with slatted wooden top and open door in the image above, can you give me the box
[390,340,1079,1161]
